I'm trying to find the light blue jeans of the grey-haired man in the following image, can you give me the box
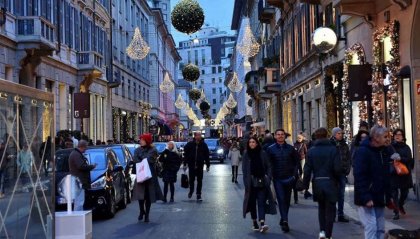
[357,207,385,239]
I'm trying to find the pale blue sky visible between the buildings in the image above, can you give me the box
[171,0,235,46]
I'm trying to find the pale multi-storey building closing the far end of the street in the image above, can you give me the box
[178,26,235,119]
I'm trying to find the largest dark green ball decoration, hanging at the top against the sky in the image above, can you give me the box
[171,0,204,34]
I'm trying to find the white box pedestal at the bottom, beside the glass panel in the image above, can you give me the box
[55,211,92,239]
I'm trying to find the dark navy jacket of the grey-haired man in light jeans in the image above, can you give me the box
[353,139,391,207]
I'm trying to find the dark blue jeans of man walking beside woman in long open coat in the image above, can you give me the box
[273,177,295,222]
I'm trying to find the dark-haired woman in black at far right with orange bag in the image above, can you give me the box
[391,129,414,220]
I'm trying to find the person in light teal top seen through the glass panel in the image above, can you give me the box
[16,144,34,193]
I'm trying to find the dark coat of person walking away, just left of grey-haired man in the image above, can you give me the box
[303,139,342,203]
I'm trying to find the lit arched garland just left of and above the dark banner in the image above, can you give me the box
[341,43,367,142]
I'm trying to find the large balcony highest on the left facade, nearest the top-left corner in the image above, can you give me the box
[16,16,56,53]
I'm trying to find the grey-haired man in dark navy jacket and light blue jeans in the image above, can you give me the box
[353,125,393,239]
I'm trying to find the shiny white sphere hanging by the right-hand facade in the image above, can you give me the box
[312,27,337,54]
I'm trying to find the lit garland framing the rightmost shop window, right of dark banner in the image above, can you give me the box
[372,21,400,129]
